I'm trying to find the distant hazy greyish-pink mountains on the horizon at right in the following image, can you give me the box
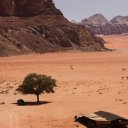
[80,14,128,35]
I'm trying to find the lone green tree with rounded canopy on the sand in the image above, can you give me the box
[16,73,57,103]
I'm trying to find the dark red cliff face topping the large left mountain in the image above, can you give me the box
[0,0,62,17]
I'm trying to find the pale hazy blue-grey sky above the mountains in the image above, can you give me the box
[53,0,128,21]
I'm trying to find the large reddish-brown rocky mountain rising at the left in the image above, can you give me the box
[0,0,105,56]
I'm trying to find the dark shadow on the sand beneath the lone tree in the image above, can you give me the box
[12,101,51,106]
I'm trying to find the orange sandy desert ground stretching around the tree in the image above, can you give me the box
[0,35,128,128]
